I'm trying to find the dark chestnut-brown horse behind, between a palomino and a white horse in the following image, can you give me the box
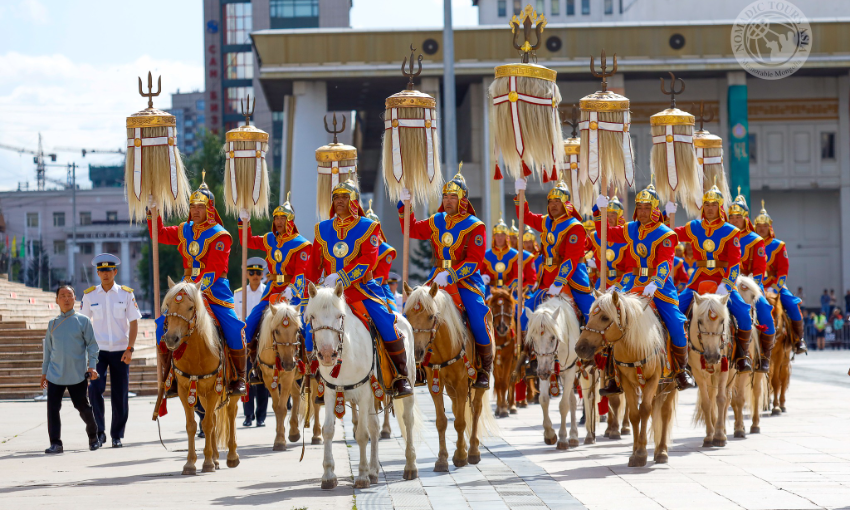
[487,288,517,418]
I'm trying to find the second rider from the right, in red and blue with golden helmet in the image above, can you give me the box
[729,194,776,373]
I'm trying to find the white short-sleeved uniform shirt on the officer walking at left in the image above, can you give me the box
[80,283,142,351]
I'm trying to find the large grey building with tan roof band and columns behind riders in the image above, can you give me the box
[251,14,850,296]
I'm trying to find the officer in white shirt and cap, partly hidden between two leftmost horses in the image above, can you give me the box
[233,257,269,427]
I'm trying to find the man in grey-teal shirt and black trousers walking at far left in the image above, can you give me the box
[41,285,100,454]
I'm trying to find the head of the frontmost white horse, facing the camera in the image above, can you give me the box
[304,281,345,367]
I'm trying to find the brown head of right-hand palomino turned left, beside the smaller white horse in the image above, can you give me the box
[576,291,644,360]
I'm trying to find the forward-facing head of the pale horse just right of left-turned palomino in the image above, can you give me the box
[690,293,729,365]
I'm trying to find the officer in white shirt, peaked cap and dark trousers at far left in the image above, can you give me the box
[80,253,142,448]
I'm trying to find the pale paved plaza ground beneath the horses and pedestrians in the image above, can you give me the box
[0,351,850,510]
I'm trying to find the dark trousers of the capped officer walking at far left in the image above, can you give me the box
[89,351,130,439]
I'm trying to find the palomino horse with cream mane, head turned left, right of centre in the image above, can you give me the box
[576,292,678,467]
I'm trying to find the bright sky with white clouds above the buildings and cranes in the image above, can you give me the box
[0,0,478,190]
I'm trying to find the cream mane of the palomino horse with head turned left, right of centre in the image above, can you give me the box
[596,292,664,358]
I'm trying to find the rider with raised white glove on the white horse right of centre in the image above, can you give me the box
[514,179,594,318]
